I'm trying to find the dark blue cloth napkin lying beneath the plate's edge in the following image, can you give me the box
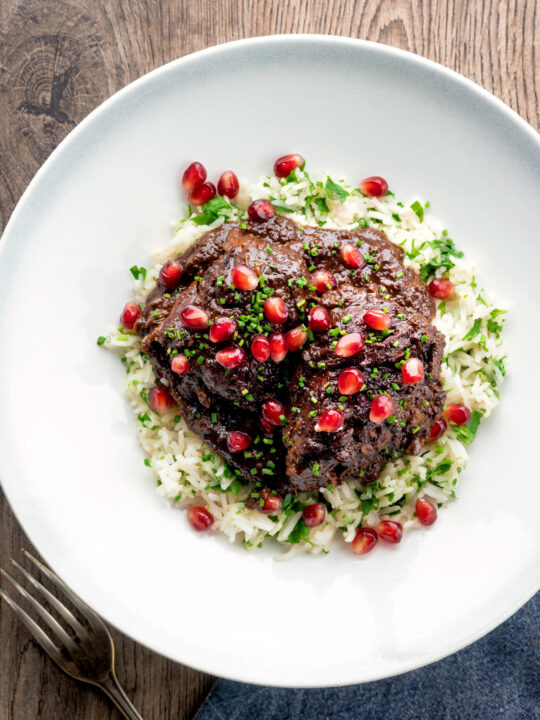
[195,593,540,720]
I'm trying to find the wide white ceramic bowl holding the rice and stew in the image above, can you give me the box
[0,36,540,686]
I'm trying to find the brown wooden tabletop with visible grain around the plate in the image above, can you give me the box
[0,0,540,720]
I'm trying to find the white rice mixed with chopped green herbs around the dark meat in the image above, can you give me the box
[98,169,505,557]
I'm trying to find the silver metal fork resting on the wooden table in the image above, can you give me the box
[0,550,142,720]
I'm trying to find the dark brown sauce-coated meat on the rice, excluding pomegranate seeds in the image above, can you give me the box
[136,217,445,507]
